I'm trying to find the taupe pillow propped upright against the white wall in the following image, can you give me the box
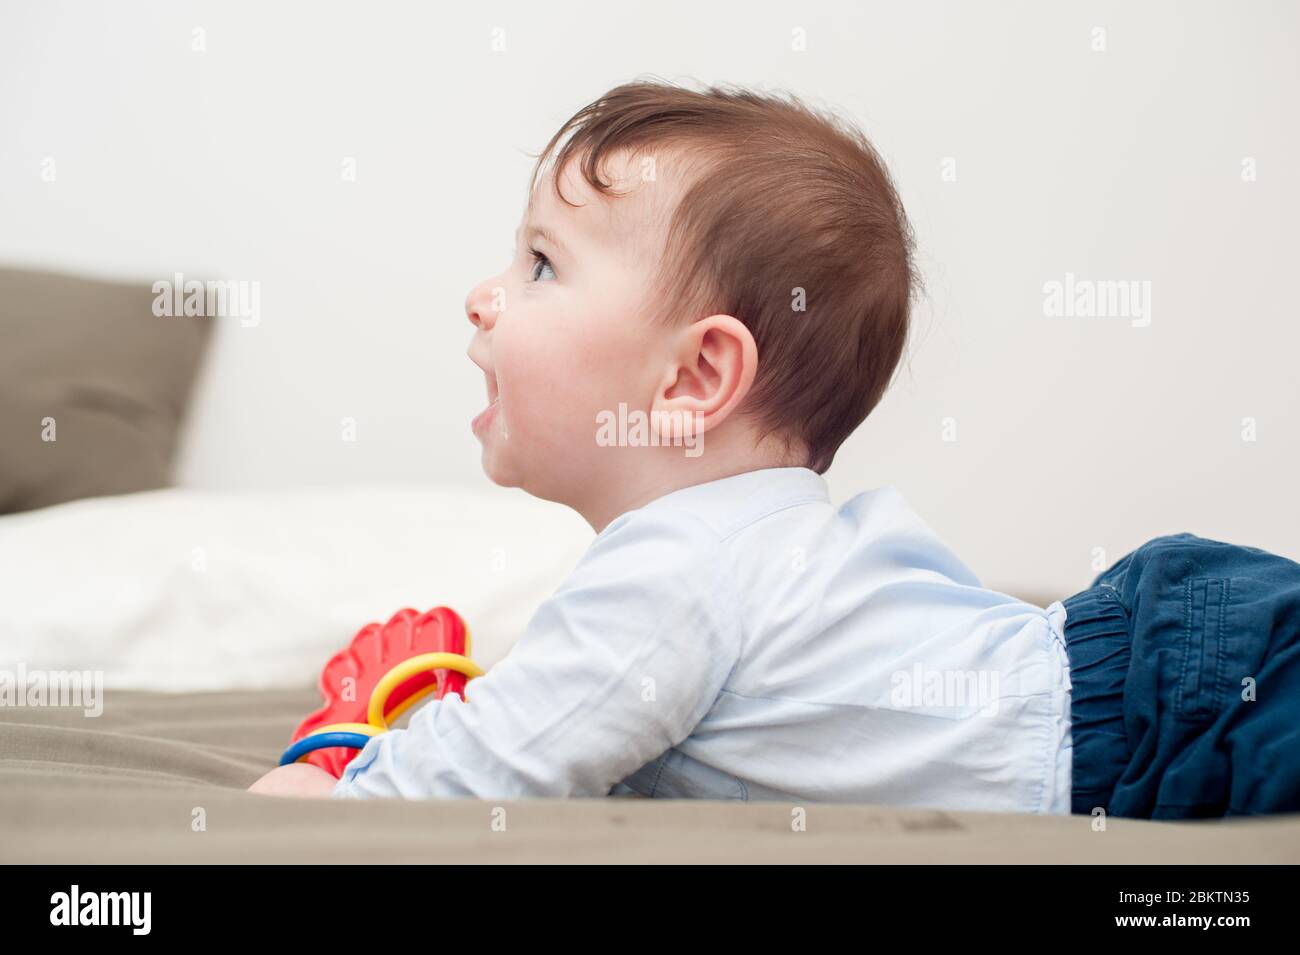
[0,269,215,513]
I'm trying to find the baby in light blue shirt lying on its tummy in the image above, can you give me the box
[252,82,1300,815]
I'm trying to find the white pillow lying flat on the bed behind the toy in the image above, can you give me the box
[0,486,593,691]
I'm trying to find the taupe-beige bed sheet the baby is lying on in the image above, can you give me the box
[0,689,1300,864]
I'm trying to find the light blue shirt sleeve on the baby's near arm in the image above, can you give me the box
[333,505,740,799]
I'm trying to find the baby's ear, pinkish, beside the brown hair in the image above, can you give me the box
[654,314,758,430]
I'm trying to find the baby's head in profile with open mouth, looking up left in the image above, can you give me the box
[465,82,913,530]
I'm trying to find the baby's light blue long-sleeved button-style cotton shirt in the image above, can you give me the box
[334,468,1071,813]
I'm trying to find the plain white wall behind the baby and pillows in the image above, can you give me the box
[0,0,1300,595]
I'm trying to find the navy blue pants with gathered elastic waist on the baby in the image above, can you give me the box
[1063,534,1300,819]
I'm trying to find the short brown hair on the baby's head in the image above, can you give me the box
[529,81,915,473]
